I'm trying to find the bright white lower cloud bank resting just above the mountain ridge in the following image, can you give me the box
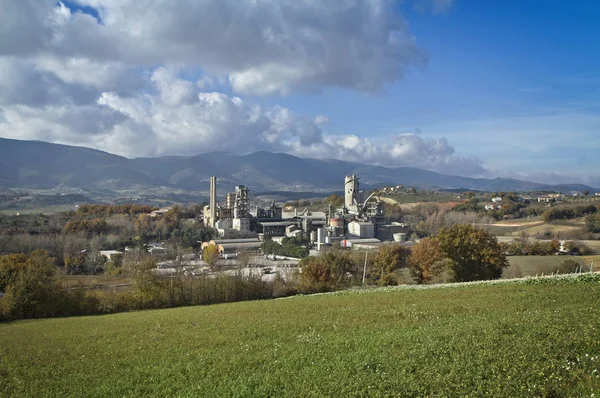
[0,63,483,175]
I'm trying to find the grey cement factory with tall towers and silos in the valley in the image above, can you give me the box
[203,175,409,253]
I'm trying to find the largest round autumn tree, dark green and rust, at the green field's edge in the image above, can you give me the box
[437,224,509,282]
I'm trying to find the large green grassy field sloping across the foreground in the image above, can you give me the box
[0,277,600,397]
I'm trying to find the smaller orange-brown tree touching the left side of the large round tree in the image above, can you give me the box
[406,238,446,284]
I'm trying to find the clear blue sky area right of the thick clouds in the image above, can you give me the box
[278,0,600,173]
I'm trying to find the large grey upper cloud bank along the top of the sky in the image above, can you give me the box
[0,0,426,95]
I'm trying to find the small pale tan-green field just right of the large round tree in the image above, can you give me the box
[502,256,588,279]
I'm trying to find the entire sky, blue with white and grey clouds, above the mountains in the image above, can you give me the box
[0,0,600,187]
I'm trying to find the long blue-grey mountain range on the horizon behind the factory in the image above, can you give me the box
[0,138,598,192]
